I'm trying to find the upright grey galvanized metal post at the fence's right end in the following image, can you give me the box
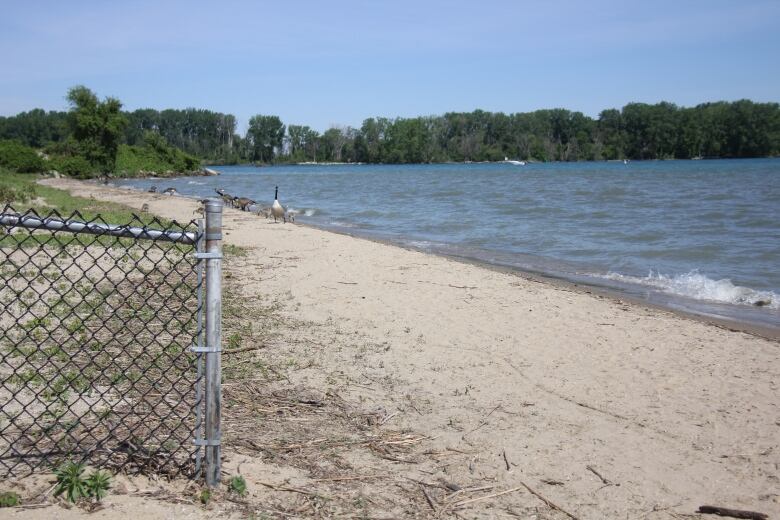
[204,199,222,487]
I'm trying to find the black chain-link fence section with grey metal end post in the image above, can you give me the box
[0,203,221,484]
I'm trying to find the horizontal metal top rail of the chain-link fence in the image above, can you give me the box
[0,211,198,245]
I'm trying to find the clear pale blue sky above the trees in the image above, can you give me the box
[0,0,780,132]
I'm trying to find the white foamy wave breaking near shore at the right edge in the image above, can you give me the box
[599,270,780,310]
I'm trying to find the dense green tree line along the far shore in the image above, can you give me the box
[0,95,780,164]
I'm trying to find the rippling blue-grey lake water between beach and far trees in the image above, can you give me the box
[114,159,780,327]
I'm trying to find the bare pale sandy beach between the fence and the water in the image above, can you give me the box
[13,180,780,519]
